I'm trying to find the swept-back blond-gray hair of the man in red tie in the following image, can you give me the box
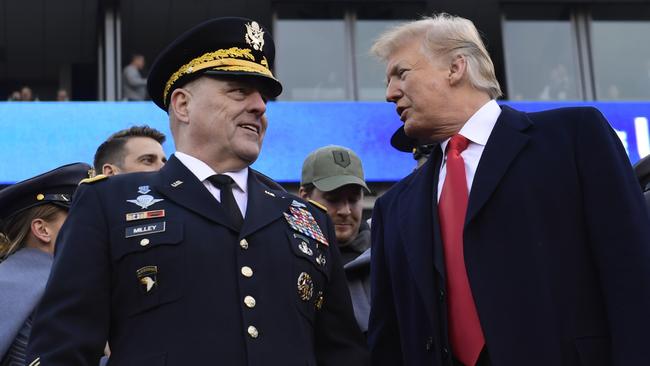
[370,13,503,99]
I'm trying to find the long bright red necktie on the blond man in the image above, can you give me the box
[438,135,485,366]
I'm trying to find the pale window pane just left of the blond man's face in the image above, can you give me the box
[354,20,403,100]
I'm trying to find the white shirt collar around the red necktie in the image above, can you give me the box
[438,99,501,201]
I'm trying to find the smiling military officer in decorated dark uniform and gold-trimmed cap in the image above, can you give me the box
[28,18,367,366]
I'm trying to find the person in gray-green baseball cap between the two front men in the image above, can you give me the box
[298,145,370,333]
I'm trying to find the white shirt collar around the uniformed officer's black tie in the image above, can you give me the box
[174,151,248,217]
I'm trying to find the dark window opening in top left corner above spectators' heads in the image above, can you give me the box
[0,0,98,101]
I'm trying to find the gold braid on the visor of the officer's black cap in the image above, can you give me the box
[163,47,275,106]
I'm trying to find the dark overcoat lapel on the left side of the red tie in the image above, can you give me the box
[398,147,444,324]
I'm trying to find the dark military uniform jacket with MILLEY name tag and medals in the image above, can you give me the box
[28,157,367,366]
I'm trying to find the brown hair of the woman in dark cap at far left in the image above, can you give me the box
[0,204,64,262]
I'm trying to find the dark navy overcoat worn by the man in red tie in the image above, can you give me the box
[368,106,650,366]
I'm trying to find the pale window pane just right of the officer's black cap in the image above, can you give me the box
[273,19,349,101]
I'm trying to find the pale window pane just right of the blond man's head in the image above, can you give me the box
[503,20,582,100]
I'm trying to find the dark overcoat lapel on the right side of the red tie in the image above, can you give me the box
[465,106,532,225]
